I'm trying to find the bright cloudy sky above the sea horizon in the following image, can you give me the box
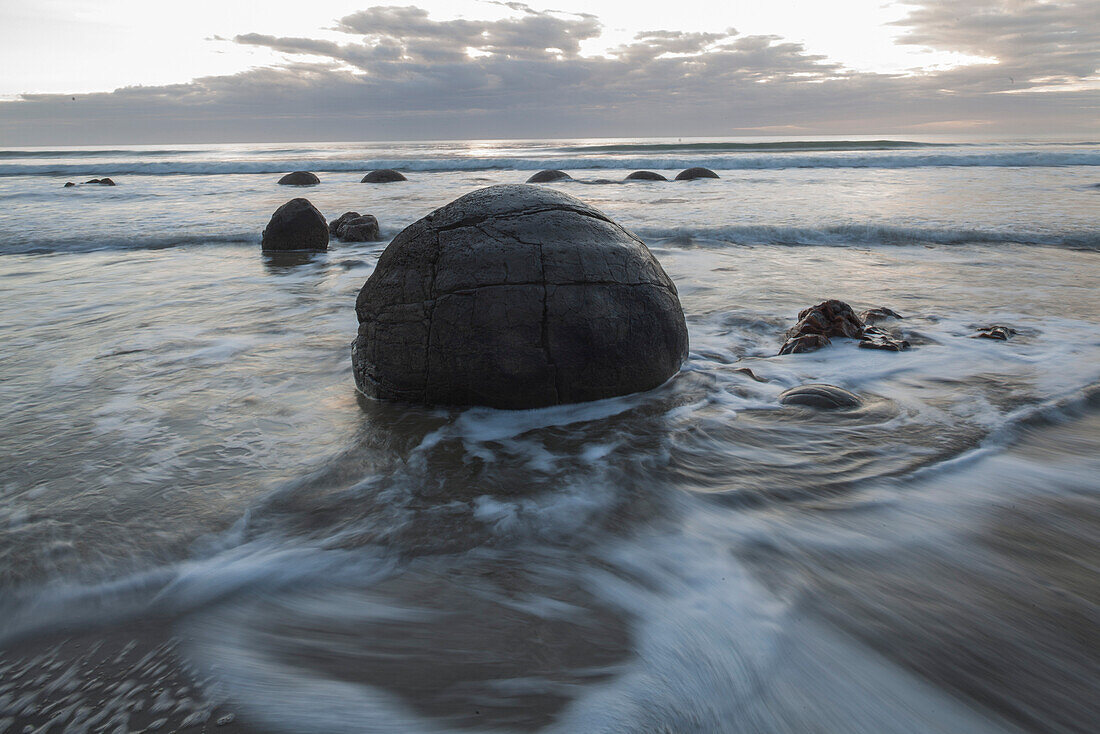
[0,0,1100,145]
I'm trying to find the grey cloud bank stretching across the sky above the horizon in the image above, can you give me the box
[0,0,1098,144]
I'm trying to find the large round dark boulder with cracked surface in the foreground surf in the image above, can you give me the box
[352,184,688,409]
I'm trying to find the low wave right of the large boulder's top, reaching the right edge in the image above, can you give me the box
[634,224,1100,250]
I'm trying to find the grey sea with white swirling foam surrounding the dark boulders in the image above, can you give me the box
[0,136,1100,734]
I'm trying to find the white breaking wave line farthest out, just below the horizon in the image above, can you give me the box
[0,150,1100,178]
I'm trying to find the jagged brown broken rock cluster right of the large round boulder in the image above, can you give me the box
[779,299,910,354]
